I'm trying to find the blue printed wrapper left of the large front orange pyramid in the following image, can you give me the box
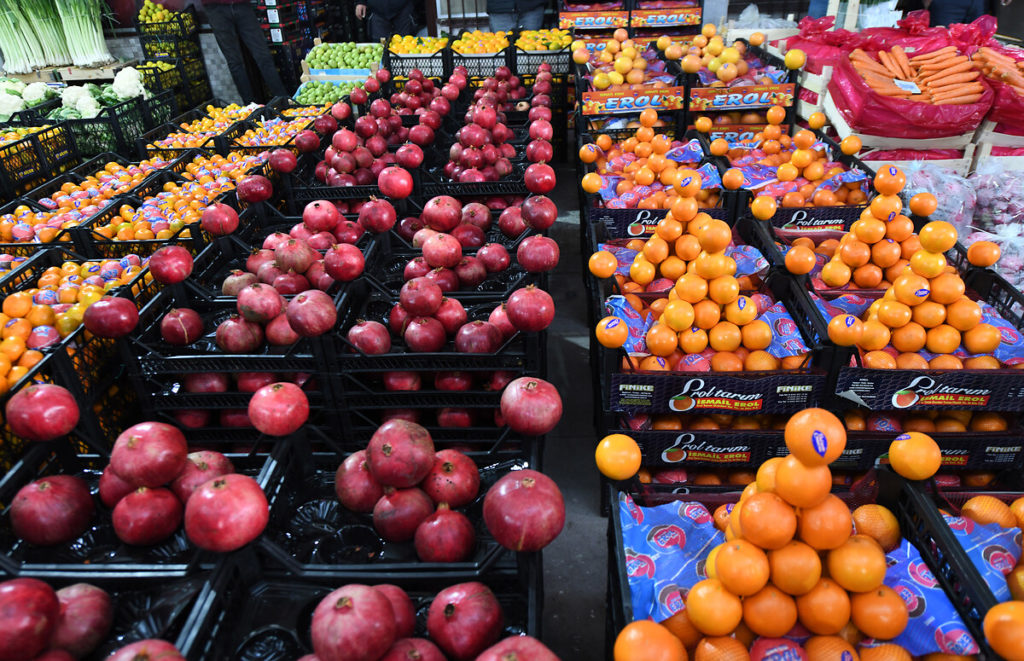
[618,493,725,622]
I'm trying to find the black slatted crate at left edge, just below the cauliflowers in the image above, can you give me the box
[0,124,81,199]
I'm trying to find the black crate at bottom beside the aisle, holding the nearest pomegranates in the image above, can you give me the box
[178,555,544,661]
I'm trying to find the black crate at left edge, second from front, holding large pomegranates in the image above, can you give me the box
[0,443,273,581]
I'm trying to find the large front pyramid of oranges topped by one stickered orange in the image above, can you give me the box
[614,408,910,661]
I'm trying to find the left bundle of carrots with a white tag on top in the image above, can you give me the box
[850,46,984,105]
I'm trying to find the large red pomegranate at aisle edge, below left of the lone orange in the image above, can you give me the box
[483,469,565,550]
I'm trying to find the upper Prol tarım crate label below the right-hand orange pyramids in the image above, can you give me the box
[836,367,1024,410]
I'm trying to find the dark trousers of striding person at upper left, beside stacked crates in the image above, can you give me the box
[206,3,289,103]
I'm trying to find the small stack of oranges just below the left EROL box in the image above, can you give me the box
[580,108,719,210]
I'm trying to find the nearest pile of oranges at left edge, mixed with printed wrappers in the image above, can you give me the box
[0,255,148,395]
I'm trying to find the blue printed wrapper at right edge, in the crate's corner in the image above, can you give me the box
[942,514,1022,602]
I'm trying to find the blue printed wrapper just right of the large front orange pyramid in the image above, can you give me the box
[860,539,978,656]
